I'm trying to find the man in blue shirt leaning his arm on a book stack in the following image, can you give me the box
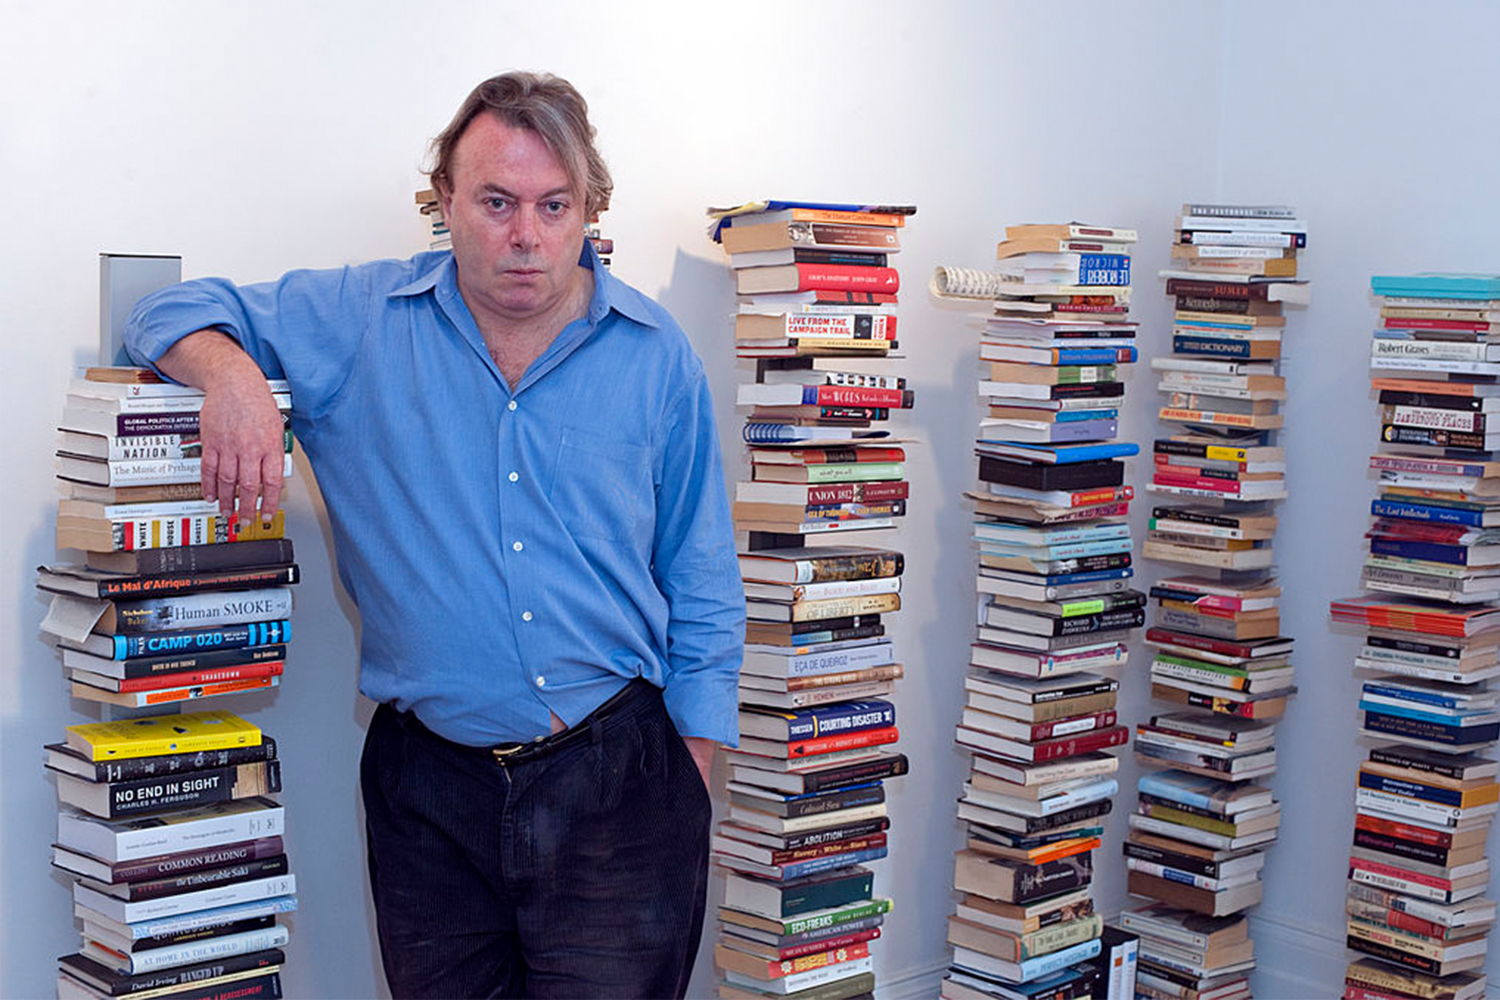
[126,73,744,997]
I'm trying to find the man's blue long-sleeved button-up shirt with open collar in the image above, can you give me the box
[125,241,744,745]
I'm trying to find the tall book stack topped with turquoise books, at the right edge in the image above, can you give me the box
[1331,274,1500,997]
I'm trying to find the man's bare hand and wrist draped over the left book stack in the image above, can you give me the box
[156,328,285,523]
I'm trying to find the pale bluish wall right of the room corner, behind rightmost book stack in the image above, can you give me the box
[1218,0,1500,996]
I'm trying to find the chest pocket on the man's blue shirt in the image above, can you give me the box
[548,427,656,549]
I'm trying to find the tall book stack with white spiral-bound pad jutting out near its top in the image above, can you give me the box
[933,223,1146,1000]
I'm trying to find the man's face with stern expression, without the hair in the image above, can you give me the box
[443,114,584,321]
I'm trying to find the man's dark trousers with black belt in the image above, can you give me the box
[360,679,713,997]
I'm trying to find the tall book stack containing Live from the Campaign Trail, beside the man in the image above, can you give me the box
[710,201,915,1000]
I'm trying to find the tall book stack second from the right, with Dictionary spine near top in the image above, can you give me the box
[1125,204,1308,1000]
